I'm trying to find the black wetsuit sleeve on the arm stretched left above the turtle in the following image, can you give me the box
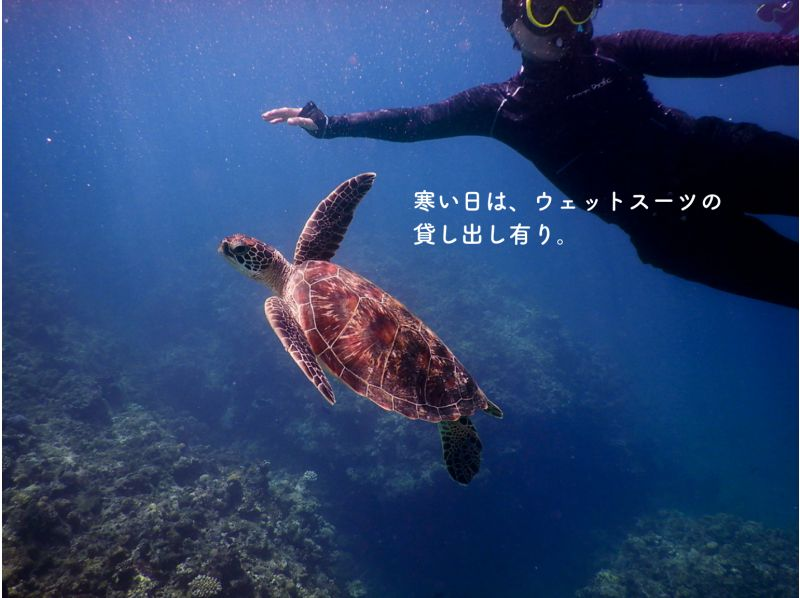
[300,85,505,141]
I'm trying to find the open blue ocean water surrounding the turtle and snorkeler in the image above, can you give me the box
[3,0,798,596]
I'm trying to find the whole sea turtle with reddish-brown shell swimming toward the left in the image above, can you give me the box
[219,172,503,484]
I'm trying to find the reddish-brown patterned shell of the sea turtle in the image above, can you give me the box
[284,260,487,422]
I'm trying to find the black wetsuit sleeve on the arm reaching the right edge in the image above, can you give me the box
[595,30,797,77]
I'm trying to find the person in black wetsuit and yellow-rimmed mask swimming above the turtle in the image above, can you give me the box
[262,0,799,308]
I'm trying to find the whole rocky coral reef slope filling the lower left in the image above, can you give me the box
[3,274,352,598]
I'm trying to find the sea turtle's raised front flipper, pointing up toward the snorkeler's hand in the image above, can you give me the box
[294,172,375,265]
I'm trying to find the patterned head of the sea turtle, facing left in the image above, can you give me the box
[217,233,291,295]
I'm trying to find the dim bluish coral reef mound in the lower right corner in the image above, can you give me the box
[577,511,798,598]
